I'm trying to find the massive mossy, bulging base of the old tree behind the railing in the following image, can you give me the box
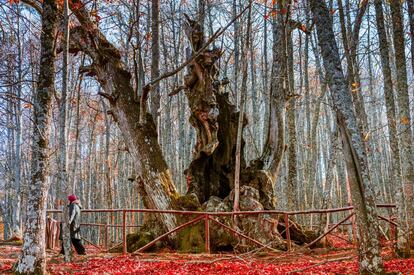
[121,185,317,253]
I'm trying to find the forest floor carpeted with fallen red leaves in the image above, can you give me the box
[0,237,414,274]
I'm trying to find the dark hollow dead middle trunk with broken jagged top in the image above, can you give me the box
[182,15,241,203]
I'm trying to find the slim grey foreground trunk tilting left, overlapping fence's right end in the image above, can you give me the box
[310,0,383,274]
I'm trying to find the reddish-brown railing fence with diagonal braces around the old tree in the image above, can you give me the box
[47,204,397,254]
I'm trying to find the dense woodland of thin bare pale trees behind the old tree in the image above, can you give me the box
[0,0,414,260]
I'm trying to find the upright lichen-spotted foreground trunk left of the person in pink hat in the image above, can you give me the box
[15,0,58,274]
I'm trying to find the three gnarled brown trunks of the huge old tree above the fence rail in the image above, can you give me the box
[70,0,312,252]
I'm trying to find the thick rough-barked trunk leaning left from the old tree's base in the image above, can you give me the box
[70,0,178,235]
